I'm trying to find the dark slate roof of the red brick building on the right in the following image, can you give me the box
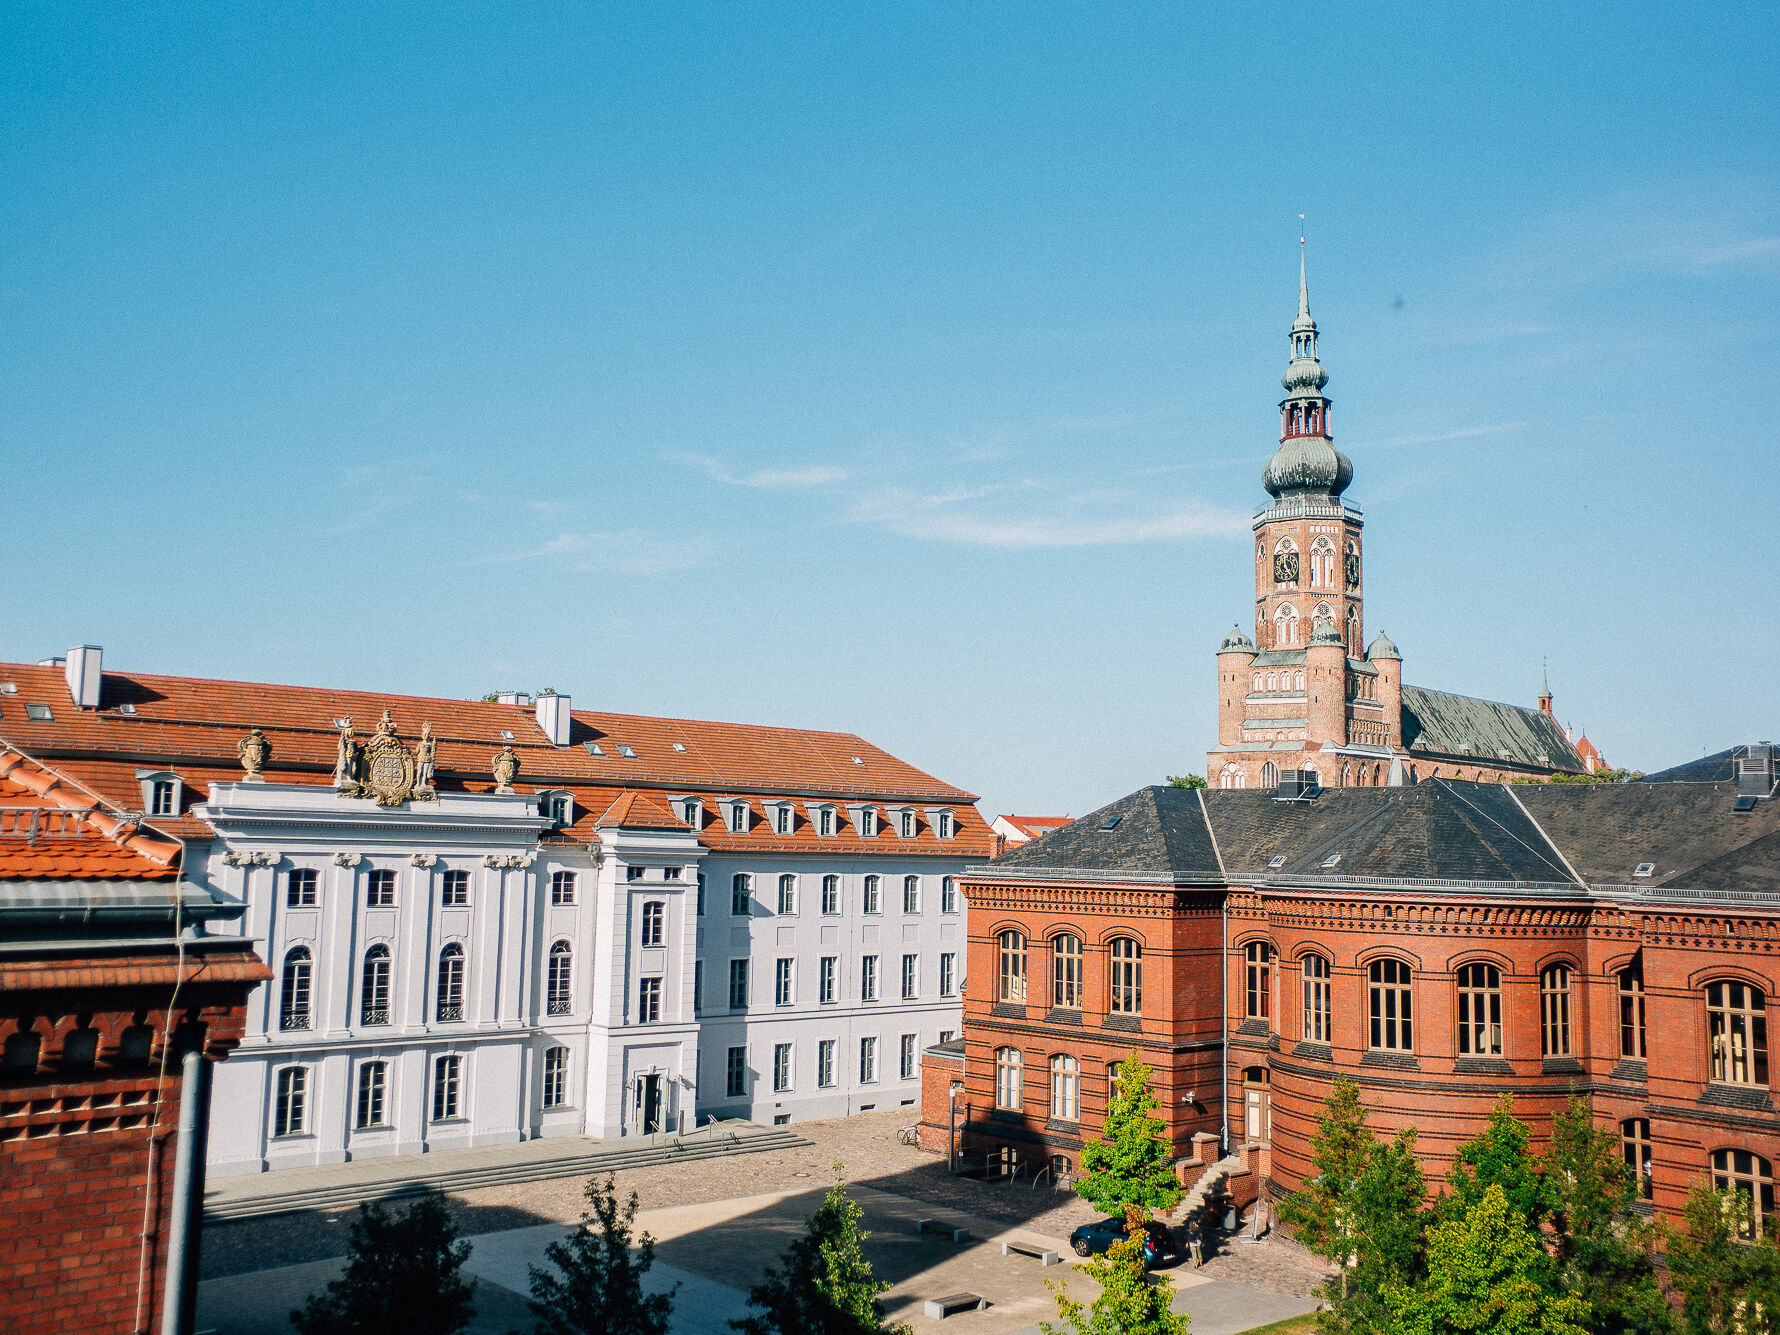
[981,780,1780,895]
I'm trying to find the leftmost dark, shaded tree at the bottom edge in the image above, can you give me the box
[290,1191,475,1335]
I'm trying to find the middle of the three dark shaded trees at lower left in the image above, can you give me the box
[530,1175,680,1335]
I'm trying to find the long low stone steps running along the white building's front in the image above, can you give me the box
[205,1123,810,1223]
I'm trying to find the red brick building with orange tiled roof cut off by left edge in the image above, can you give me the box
[0,747,267,1335]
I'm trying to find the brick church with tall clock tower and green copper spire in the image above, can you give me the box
[1205,256,1586,789]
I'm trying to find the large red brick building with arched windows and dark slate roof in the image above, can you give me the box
[924,773,1780,1214]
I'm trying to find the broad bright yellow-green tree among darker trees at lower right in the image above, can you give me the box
[1380,1182,1588,1335]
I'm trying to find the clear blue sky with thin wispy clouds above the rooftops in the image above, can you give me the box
[0,4,1780,813]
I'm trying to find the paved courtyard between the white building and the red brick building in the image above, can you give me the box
[199,1113,1321,1335]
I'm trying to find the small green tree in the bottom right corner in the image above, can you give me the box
[1663,1182,1780,1335]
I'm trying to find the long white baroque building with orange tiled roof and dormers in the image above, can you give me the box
[0,646,993,1175]
